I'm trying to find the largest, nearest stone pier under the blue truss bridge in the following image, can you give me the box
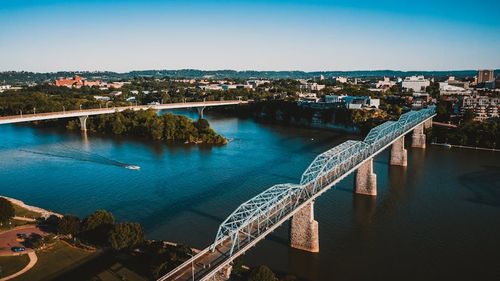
[290,202,319,253]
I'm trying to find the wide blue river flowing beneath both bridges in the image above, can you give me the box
[0,111,500,280]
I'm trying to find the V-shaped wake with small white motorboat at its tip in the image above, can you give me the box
[19,144,141,170]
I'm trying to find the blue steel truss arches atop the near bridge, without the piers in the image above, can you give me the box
[210,106,436,256]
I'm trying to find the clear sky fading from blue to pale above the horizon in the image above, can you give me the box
[0,0,500,71]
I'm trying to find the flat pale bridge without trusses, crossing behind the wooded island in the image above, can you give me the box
[0,100,244,131]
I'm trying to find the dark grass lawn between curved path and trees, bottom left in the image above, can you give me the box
[14,241,96,281]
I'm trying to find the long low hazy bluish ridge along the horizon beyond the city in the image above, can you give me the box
[0,69,500,84]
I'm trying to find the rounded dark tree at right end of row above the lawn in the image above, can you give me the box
[108,223,144,250]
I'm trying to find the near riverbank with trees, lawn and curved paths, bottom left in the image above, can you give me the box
[0,196,195,281]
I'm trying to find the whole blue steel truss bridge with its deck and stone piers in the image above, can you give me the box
[158,106,436,281]
